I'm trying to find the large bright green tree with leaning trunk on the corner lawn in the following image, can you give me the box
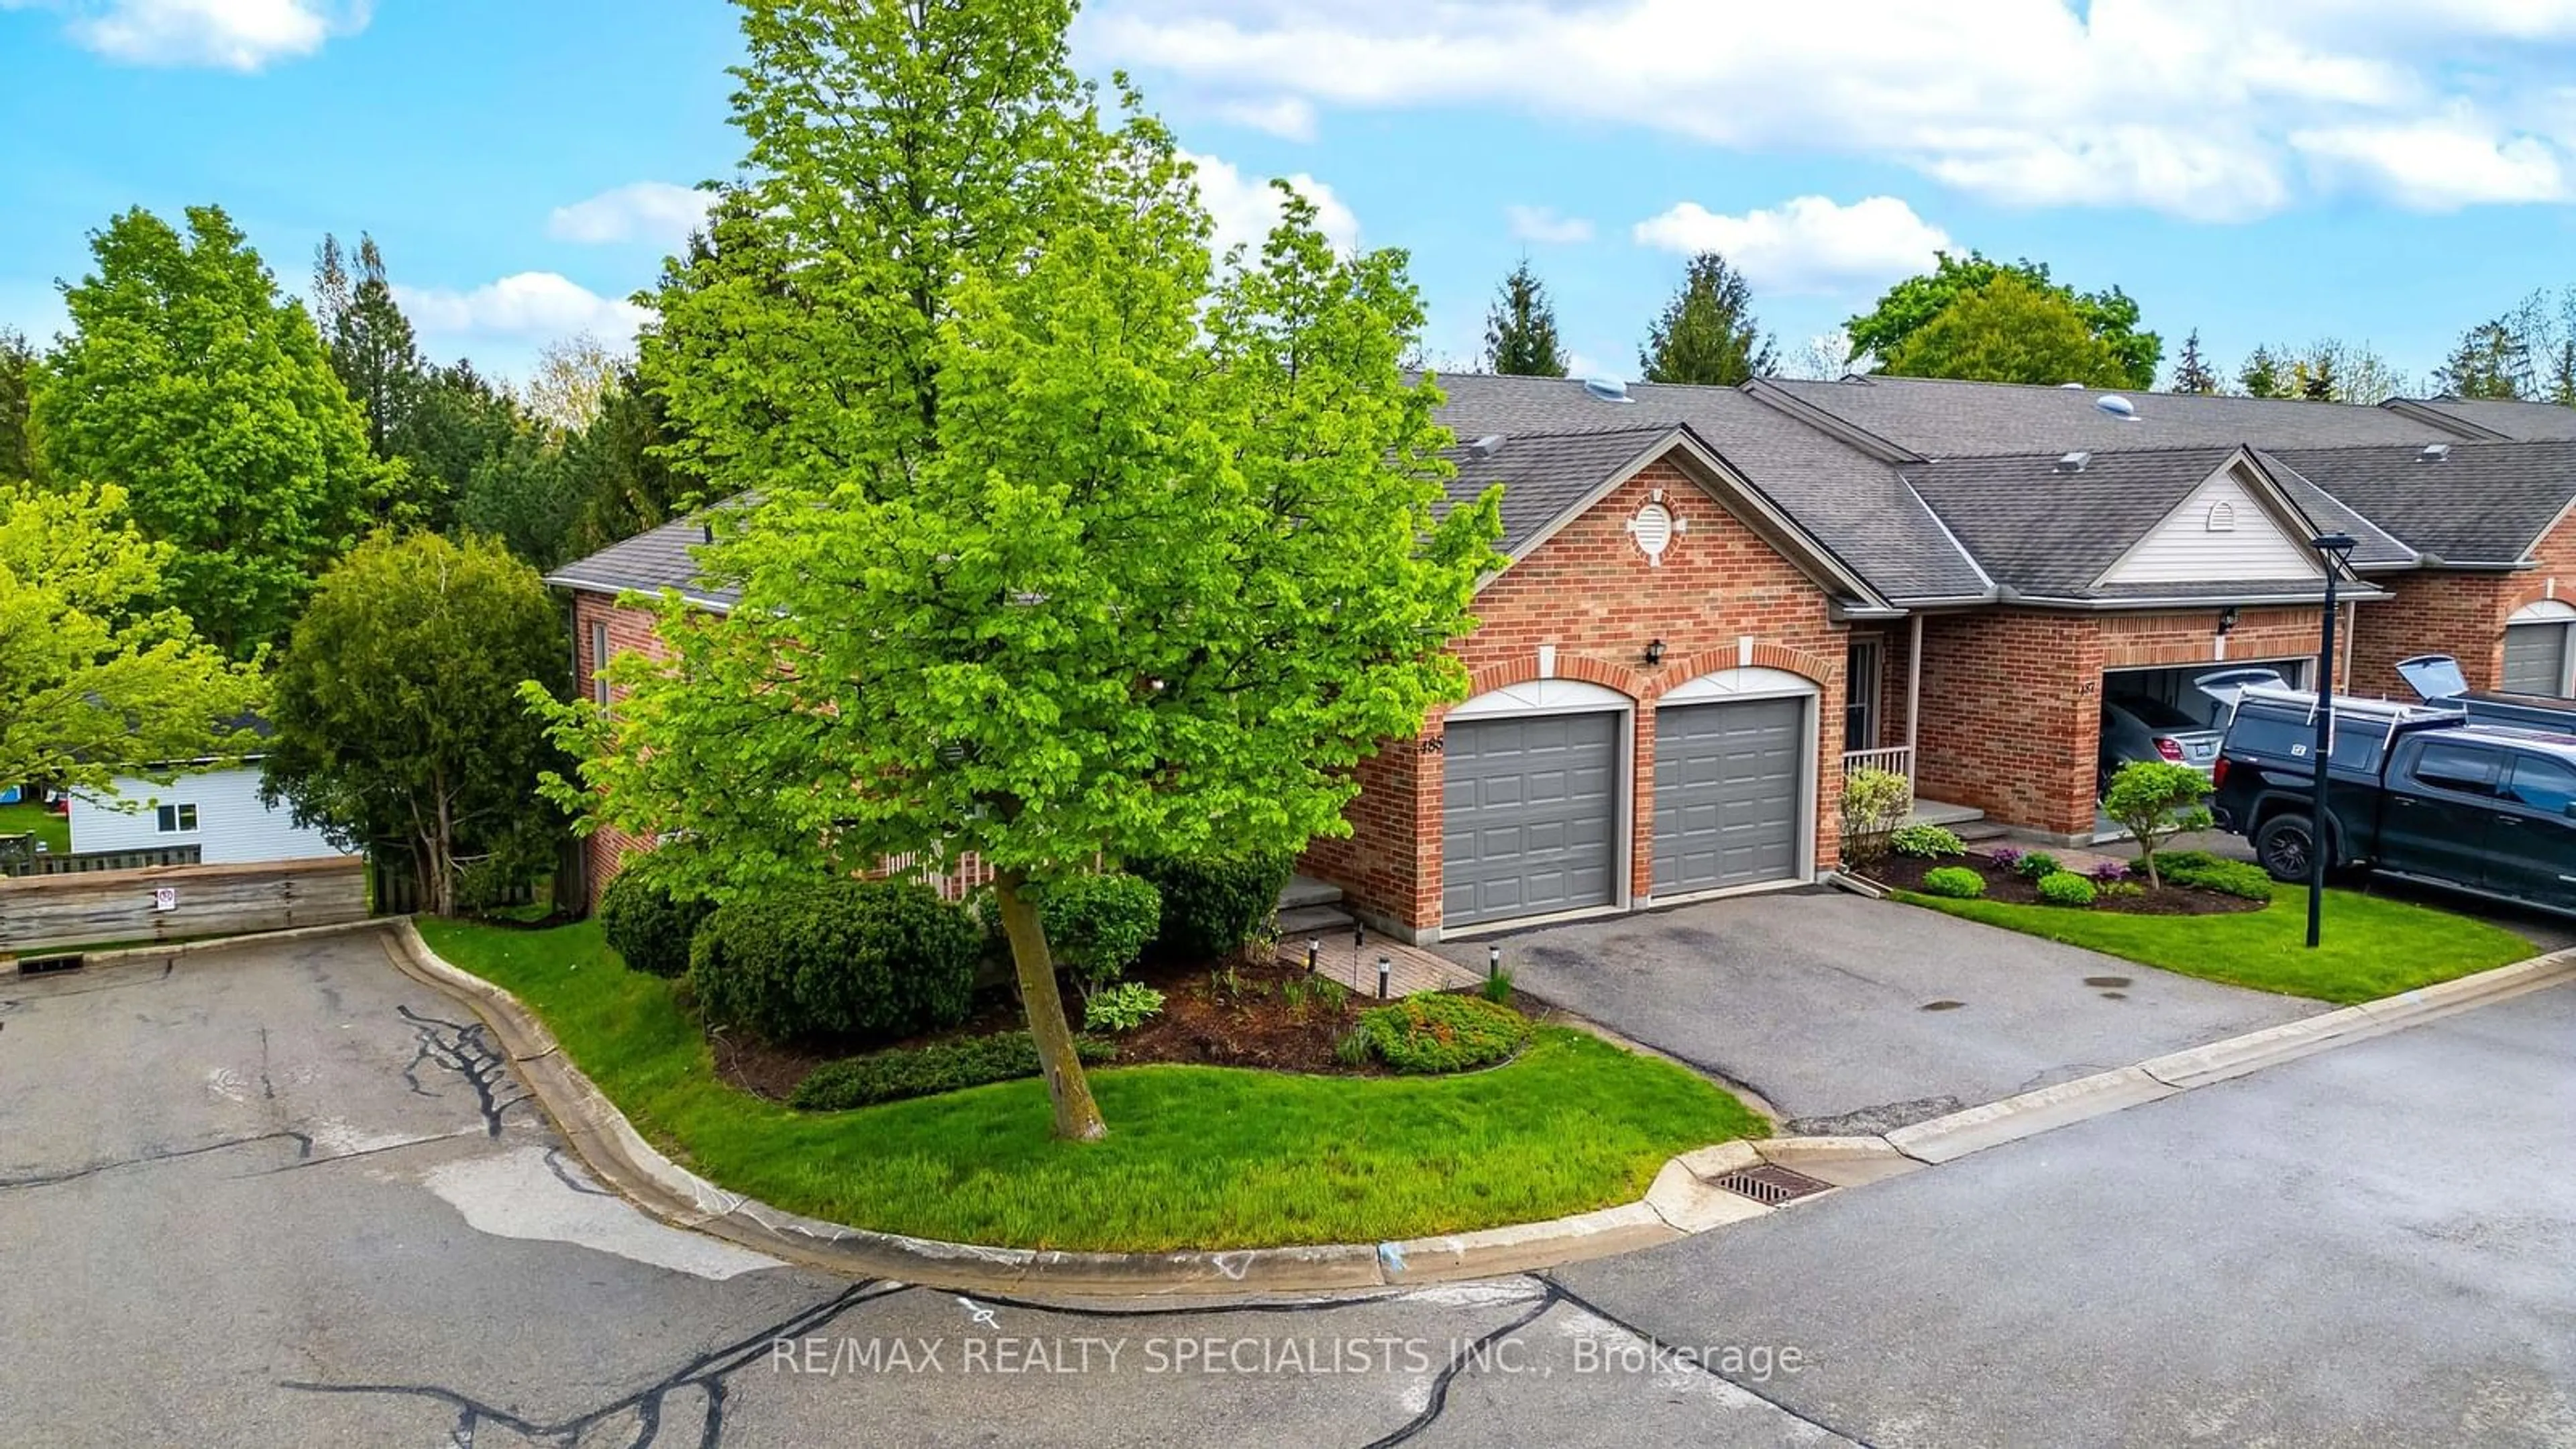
[551,0,1499,1140]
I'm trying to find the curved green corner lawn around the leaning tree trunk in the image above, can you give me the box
[420,920,1767,1250]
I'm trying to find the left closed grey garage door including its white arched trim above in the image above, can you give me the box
[1440,678,1635,933]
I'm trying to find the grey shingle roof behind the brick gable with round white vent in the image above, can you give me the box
[1438,374,1986,603]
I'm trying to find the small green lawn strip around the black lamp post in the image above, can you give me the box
[1896,884,2535,1006]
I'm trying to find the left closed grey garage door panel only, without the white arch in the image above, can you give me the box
[1440,714,1620,926]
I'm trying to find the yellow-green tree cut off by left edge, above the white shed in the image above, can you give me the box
[0,482,260,794]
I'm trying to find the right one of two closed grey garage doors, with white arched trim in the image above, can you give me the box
[1654,665,1824,902]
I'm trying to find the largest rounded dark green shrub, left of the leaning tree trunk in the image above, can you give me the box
[688,879,984,1042]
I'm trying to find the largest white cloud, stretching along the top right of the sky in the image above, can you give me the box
[1085,0,2576,219]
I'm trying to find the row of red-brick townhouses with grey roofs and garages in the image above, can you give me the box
[551,366,2576,941]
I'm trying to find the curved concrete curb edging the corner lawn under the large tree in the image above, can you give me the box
[386,920,1770,1297]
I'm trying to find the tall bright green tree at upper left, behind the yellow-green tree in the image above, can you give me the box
[36,206,384,657]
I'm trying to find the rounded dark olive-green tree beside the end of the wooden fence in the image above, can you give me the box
[263,534,570,913]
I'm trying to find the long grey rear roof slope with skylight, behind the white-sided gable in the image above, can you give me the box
[1762,376,2468,459]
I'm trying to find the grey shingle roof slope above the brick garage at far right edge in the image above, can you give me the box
[2279,441,2576,565]
